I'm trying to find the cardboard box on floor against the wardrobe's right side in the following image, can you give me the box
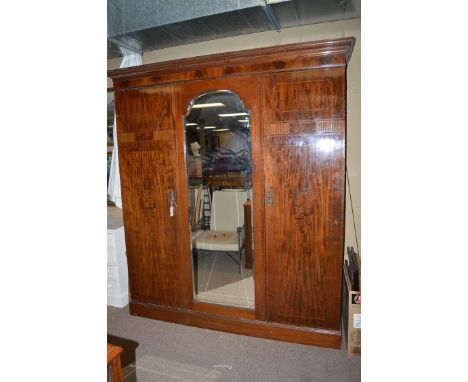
[343,267,361,355]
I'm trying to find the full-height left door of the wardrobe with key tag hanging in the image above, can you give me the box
[115,86,186,307]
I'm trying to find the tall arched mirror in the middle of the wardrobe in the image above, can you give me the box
[185,90,255,309]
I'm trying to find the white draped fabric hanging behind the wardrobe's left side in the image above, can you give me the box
[107,53,142,208]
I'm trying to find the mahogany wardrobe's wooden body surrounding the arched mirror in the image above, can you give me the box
[108,38,355,348]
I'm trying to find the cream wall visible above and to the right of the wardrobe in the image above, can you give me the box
[107,19,361,256]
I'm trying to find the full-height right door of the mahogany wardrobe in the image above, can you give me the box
[263,67,346,330]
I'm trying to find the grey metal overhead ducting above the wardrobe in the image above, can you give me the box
[107,0,361,59]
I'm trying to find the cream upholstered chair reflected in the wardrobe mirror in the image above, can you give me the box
[192,189,247,273]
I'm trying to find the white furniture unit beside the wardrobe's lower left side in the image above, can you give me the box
[107,217,128,308]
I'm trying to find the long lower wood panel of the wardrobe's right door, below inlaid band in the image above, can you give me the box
[265,134,344,327]
